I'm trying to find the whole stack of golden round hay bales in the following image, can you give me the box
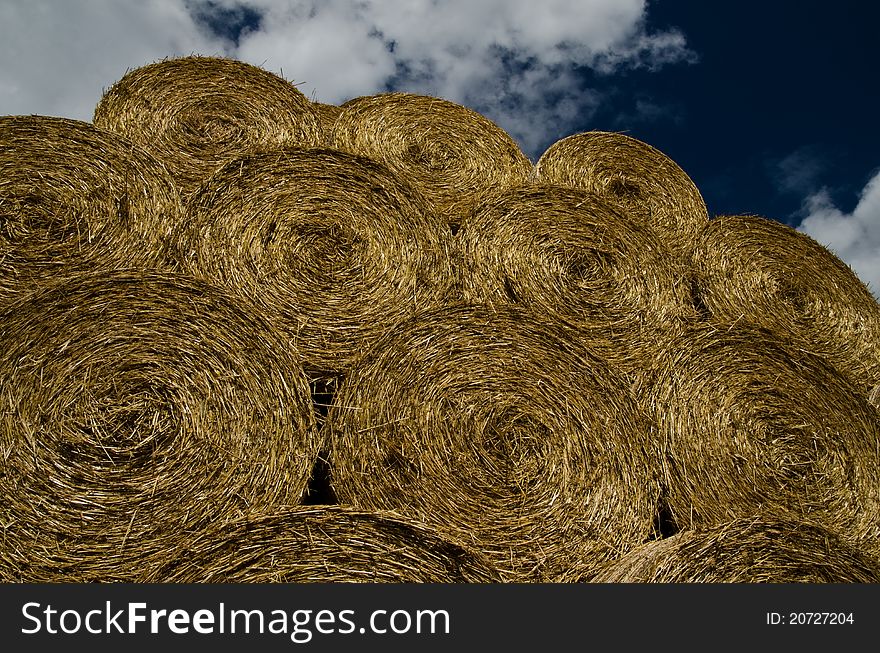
[0,57,880,582]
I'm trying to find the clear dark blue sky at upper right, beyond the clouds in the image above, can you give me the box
[583,0,880,224]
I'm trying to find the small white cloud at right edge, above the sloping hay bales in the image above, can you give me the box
[798,171,880,296]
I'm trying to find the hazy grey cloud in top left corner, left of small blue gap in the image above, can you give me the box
[0,0,224,120]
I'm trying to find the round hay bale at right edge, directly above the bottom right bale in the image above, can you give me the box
[644,323,880,540]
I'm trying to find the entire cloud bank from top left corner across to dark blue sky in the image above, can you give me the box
[0,0,692,157]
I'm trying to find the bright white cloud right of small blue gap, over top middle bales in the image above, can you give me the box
[223,0,692,158]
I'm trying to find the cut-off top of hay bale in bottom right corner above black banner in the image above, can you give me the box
[593,517,880,583]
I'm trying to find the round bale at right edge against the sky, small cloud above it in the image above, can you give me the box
[692,215,880,396]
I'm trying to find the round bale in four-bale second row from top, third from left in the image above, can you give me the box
[456,185,696,370]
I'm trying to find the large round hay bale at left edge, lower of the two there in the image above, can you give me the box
[0,272,320,582]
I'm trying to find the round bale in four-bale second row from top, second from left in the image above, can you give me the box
[177,149,452,374]
